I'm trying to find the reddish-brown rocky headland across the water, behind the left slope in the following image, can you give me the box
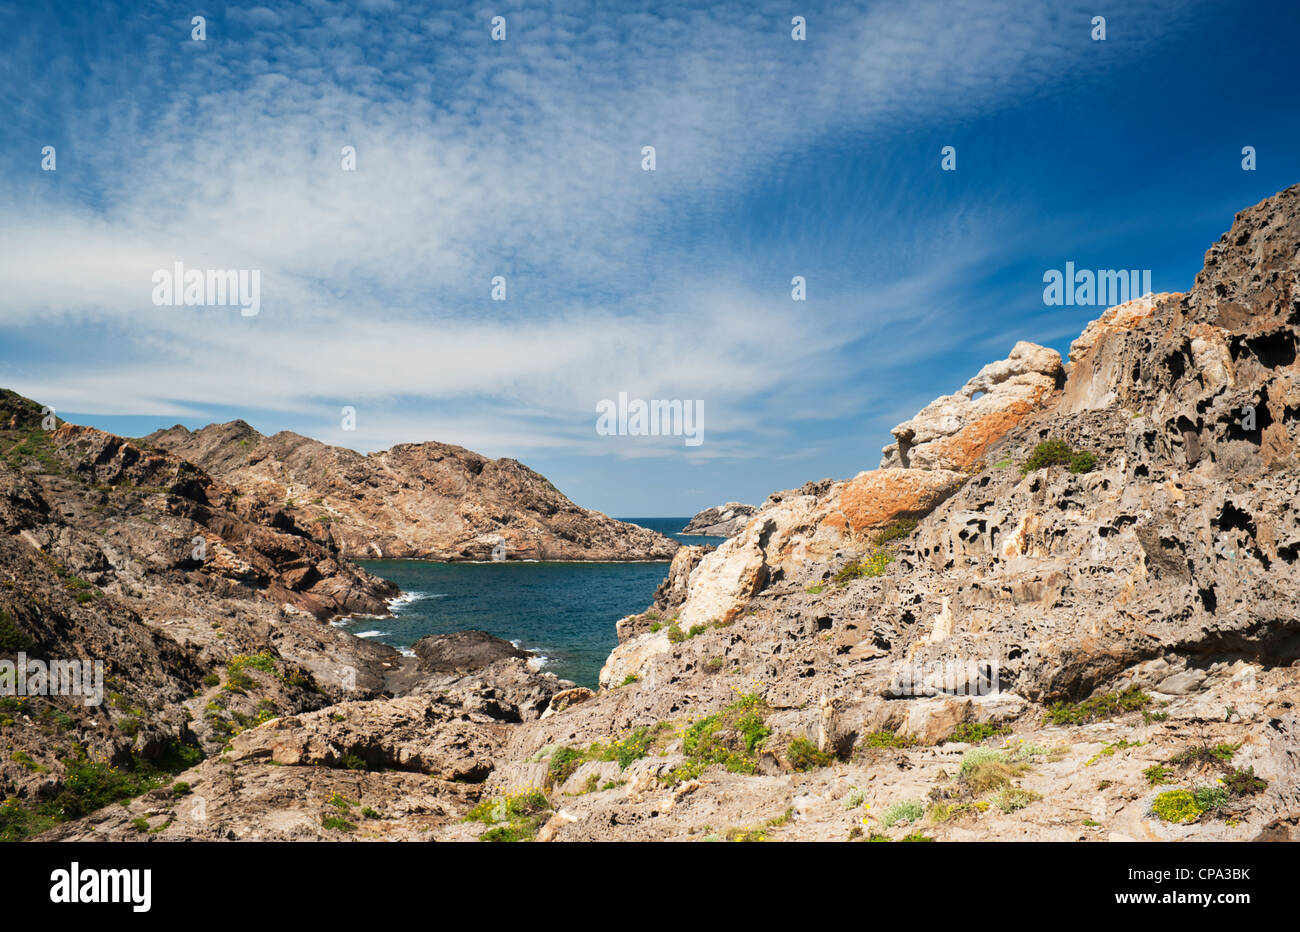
[142,421,677,560]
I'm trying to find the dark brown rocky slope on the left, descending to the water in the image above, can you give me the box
[0,391,398,812]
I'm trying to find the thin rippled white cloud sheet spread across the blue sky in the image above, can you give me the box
[0,0,1206,458]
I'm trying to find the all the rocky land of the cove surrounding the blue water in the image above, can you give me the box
[0,186,1300,841]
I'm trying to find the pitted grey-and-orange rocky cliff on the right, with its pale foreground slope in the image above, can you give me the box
[17,187,1300,841]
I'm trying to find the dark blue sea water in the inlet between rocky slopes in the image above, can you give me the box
[345,517,725,689]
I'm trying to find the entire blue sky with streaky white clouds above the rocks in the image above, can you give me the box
[0,0,1300,516]
